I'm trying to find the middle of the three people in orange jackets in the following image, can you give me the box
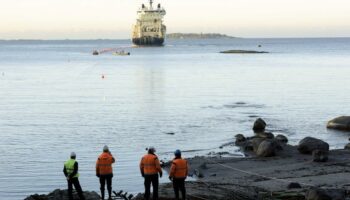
[140,147,163,200]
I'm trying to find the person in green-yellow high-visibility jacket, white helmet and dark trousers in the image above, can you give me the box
[63,152,85,200]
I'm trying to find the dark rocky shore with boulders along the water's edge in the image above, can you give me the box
[25,116,350,200]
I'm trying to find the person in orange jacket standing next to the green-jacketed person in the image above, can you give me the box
[96,145,115,200]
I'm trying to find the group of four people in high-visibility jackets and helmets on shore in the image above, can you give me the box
[63,146,188,200]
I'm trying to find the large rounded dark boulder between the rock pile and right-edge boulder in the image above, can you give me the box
[298,137,329,154]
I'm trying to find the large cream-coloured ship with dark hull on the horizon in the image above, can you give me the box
[132,0,166,46]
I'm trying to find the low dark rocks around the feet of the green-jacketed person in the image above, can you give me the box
[24,189,100,200]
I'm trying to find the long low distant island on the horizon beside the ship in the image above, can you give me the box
[166,33,236,39]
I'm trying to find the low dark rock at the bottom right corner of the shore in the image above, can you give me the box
[305,188,346,200]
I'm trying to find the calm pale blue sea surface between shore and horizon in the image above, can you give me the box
[0,38,350,200]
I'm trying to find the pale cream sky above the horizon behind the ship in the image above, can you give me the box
[0,0,350,39]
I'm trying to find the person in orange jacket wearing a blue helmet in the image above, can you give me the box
[169,150,188,200]
